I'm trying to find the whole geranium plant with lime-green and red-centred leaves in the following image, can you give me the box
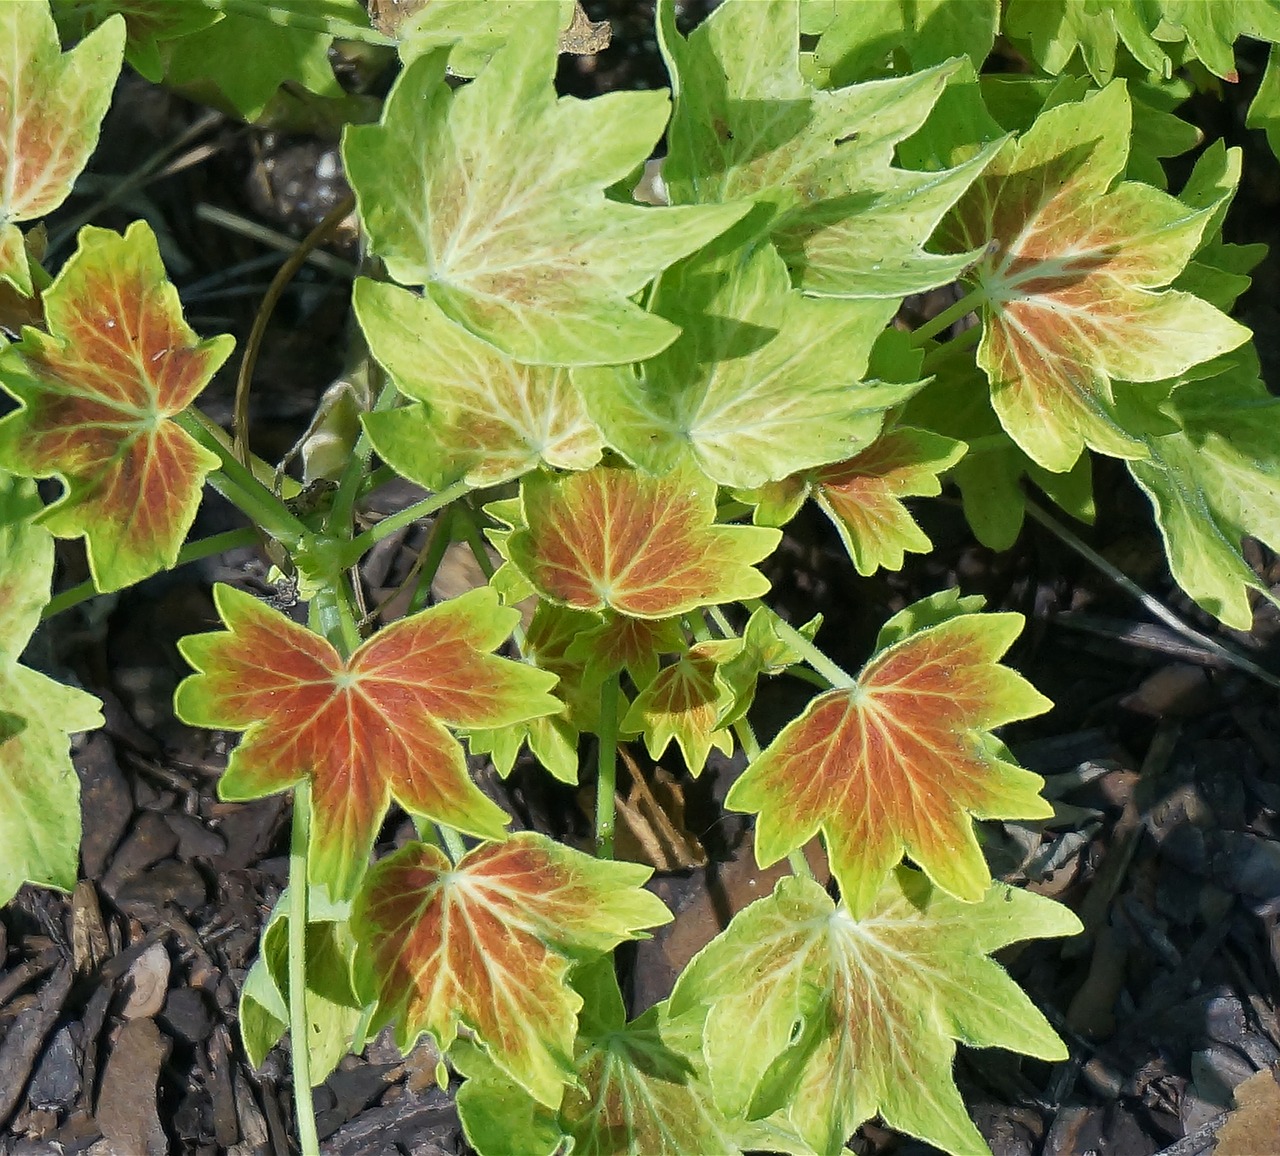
[0,0,1280,1156]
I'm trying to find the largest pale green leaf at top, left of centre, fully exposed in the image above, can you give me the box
[343,12,749,365]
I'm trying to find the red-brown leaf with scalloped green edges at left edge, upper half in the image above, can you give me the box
[0,221,233,590]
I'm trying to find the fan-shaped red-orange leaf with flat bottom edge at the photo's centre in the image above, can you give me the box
[504,466,782,618]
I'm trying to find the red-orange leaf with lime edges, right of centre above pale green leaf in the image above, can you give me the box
[726,593,1052,917]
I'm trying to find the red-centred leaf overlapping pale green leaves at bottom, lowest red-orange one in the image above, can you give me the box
[353,832,671,1107]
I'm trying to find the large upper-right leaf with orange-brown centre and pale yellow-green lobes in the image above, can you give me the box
[947,82,1249,472]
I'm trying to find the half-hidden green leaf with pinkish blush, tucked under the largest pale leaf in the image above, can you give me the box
[355,278,603,490]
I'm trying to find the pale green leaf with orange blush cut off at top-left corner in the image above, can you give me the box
[0,3,124,296]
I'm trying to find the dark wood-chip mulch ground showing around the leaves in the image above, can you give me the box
[0,0,1280,1156]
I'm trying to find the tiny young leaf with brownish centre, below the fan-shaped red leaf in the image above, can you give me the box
[621,639,741,776]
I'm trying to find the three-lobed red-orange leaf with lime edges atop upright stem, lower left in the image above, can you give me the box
[174,586,561,899]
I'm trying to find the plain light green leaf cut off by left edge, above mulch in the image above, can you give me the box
[0,471,102,906]
